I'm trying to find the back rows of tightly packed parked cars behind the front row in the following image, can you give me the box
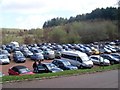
[0,42,120,64]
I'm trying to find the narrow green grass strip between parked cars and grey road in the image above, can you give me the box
[2,64,120,83]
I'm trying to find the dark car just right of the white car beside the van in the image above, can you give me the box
[101,54,120,65]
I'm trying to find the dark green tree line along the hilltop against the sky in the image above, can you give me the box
[43,7,119,28]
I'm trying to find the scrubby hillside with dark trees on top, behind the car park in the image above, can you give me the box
[2,7,120,44]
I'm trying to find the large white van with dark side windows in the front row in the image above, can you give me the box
[61,51,93,68]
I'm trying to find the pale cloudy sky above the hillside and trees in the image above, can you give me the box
[0,0,118,29]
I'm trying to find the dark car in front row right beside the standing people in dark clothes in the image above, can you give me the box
[41,63,63,73]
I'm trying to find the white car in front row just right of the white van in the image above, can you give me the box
[89,55,110,65]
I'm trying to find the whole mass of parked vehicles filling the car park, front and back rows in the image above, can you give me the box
[0,42,120,75]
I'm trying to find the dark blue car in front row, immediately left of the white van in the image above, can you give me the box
[52,59,78,70]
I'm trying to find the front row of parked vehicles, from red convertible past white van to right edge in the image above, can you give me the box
[8,51,120,75]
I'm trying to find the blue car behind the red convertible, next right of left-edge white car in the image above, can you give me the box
[13,51,26,63]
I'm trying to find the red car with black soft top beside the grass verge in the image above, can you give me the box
[8,65,34,75]
